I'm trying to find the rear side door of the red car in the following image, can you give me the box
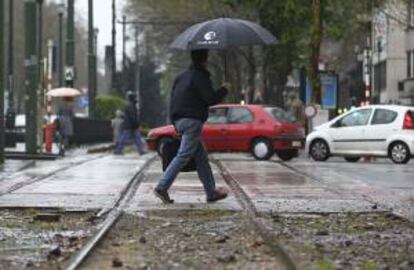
[227,107,254,151]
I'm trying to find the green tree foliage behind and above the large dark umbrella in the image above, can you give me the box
[123,0,392,109]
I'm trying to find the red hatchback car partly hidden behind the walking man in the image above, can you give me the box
[147,104,305,161]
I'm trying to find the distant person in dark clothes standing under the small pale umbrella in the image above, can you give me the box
[57,97,74,155]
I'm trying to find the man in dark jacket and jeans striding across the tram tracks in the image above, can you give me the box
[154,49,229,203]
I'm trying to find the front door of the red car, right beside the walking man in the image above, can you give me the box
[202,107,228,151]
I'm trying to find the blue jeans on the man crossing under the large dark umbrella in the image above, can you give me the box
[156,118,216,199]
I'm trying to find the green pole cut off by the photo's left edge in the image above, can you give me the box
[0,0,5,164]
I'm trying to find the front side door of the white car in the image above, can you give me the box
[328,108,372,154]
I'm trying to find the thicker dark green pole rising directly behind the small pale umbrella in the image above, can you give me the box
[65,0,75,87]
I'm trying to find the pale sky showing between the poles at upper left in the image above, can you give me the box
[49,0,131,69]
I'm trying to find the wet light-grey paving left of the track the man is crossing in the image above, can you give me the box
[0,154,153,209]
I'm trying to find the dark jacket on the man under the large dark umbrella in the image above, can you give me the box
[170,66,227,123]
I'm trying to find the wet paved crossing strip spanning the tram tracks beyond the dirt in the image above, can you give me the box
[0,150,414,217]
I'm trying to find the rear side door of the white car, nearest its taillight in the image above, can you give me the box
[366,108,399,154]
